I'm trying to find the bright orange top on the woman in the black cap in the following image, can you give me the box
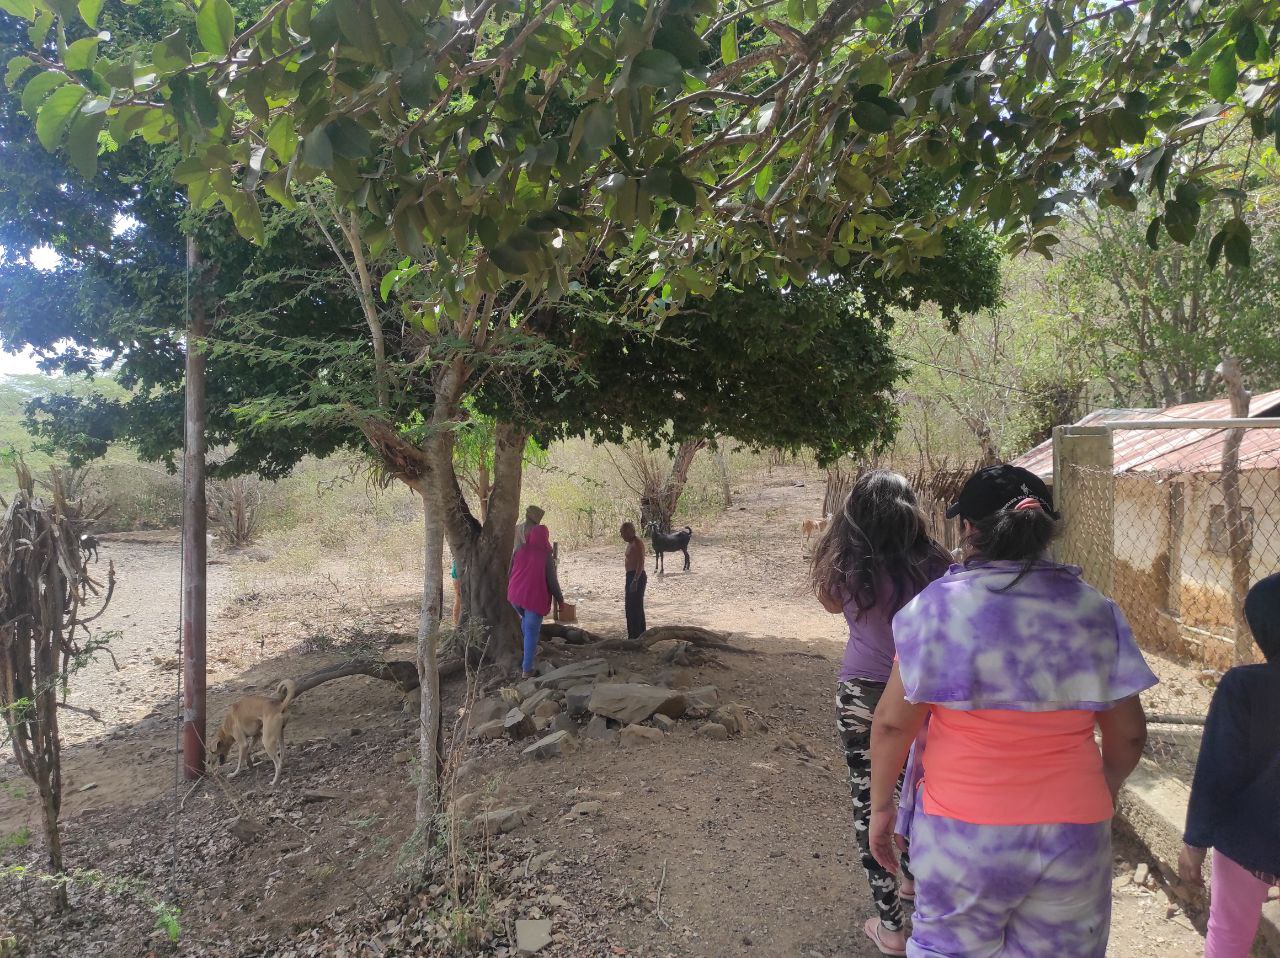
[923,706,1114,825]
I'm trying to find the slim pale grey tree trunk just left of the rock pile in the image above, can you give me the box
[415,496,444,826]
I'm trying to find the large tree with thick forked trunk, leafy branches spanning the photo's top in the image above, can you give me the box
[6,0,1280,701]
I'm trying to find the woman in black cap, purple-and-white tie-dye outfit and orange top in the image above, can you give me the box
[870,465,1156,958]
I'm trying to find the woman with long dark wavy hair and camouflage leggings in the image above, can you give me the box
[813,469,948,954]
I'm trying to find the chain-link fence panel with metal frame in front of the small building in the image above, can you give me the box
[1053,420,1280,670]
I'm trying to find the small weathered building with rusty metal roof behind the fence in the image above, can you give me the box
[1015,389,1280,666]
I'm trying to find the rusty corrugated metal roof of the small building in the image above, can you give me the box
[1014,389,1280,479]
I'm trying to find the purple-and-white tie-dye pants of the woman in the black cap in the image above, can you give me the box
[906,807,1111,958]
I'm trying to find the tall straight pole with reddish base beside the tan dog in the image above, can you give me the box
[182,237,209,780]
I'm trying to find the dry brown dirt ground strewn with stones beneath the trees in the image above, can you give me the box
[0,473,1202,958]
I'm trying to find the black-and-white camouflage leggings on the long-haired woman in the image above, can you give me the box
[836,679,911,931]
